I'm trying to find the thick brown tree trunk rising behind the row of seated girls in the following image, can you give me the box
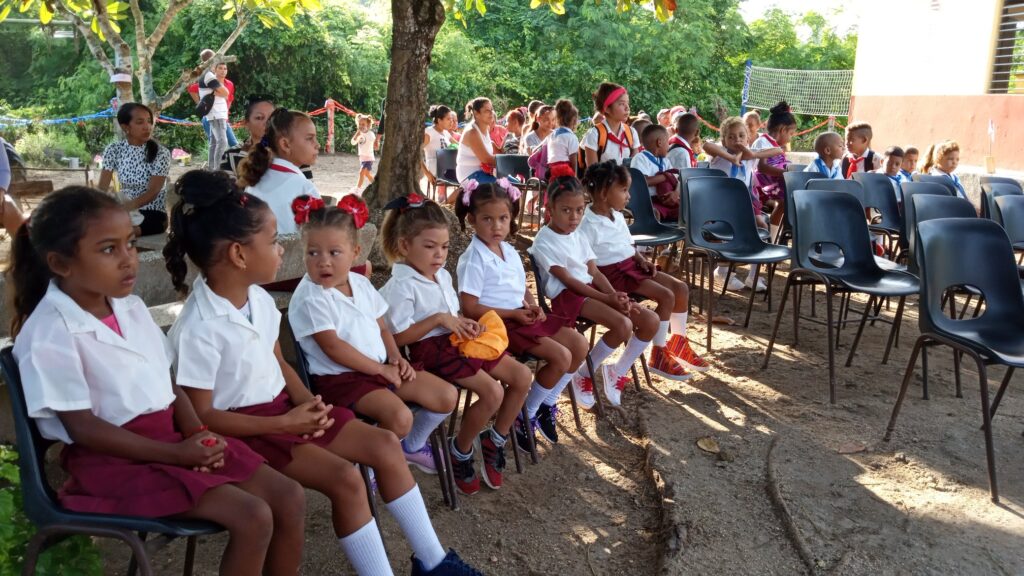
[364,0,444,211]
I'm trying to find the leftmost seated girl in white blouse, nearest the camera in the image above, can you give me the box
[7,187,305,574]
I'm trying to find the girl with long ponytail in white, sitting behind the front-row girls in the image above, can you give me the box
[239,108,319,234]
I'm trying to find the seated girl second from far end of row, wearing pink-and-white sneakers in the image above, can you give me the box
[529,176,658,408]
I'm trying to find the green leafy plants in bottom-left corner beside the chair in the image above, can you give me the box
[0,446,102,576]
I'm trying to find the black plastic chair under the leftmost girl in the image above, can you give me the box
[0,346,223,576]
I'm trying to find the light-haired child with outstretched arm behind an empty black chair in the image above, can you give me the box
[703,116,785,292]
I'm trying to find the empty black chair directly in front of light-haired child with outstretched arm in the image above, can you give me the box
[683,177,791,351]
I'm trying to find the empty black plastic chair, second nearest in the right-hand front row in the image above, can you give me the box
[762,190,919,404]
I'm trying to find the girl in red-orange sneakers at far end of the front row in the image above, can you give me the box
[580,162,709,380]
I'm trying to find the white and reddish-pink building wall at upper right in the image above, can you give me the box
[850,0,1024,172]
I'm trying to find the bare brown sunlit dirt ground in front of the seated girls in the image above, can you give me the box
[9,157,1024,576]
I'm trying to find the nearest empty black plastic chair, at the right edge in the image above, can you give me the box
[885,218,1024,502]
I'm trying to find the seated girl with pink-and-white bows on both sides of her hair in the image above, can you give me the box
[456,179,588,450]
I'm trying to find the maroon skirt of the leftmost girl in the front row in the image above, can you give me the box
[59,407,263,518]
